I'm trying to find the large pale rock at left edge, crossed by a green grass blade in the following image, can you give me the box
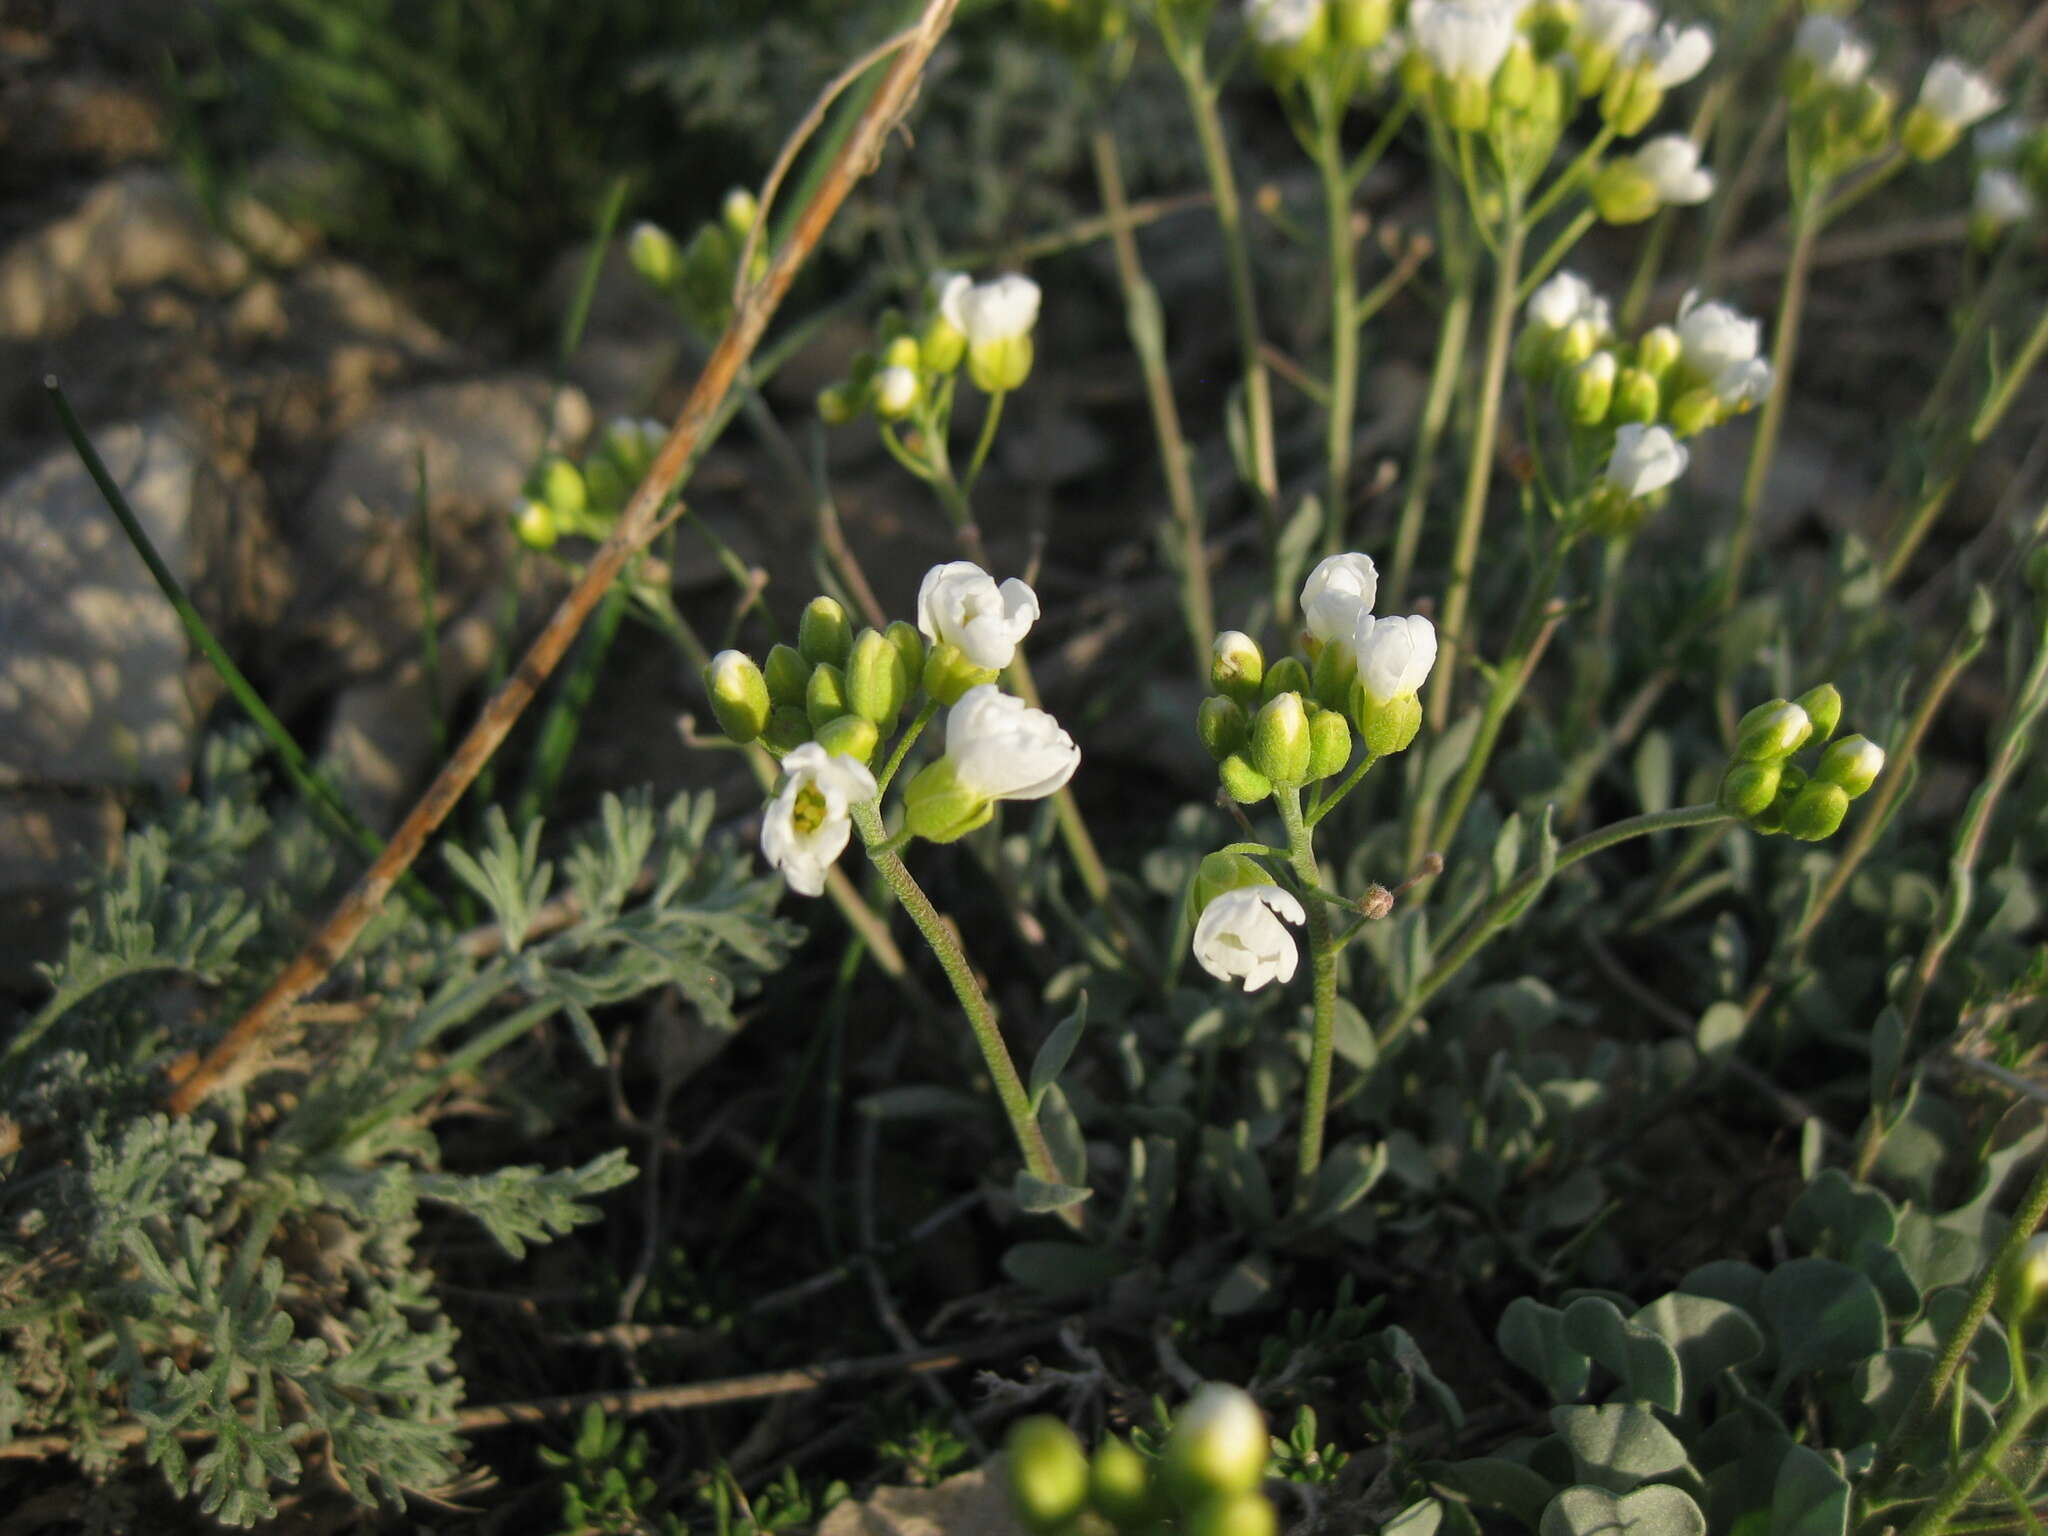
[0,418,201,788]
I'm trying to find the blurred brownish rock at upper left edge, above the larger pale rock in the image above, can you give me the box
[0,168,250,340]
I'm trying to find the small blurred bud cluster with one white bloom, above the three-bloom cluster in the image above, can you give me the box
[817,272,1040,436]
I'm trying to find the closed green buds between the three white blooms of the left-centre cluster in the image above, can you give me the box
[705,596,926,764]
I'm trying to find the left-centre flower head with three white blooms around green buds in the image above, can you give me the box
[705,561,1081,895]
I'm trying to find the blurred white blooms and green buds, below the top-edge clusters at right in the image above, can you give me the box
[1516,272,1772,535]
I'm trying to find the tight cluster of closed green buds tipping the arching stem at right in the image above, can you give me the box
[1718,682,1884,842]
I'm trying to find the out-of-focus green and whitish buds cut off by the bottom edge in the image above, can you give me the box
[1006,1382,1280,1536]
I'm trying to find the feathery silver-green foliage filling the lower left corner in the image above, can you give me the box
[0,741,799,1526]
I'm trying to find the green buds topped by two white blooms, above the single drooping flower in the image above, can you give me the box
[1196,553,1436,805]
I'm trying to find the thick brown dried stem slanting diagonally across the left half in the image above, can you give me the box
[166,0,956,1114]
